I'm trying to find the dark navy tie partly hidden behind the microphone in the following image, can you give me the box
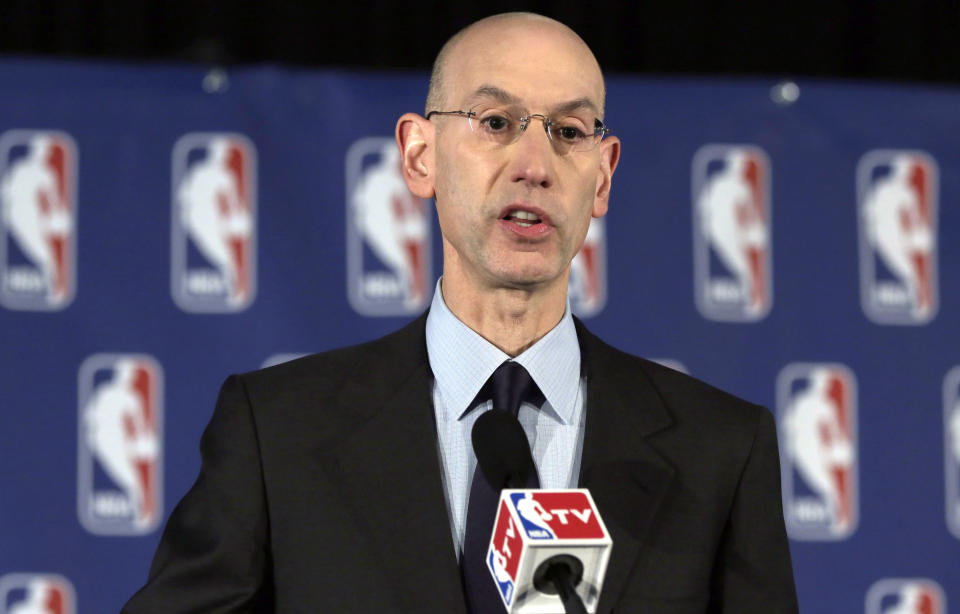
[460,360,544,614]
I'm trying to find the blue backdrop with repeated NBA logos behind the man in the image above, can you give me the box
[0,60,960,614]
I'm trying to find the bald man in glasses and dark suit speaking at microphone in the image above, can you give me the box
[125,14,797,614]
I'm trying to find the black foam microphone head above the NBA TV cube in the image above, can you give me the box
[471,409,535,490]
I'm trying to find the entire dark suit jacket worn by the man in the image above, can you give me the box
[123,317,797,614]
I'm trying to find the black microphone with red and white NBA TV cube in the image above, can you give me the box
[471,411,613,614]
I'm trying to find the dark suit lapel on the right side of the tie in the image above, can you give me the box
[576,320,675,612]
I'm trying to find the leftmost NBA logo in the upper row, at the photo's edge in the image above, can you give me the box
[0,130,77,311]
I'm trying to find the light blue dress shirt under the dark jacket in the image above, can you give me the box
[426,281,587,556]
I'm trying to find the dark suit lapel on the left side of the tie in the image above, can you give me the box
[329,316,466,613]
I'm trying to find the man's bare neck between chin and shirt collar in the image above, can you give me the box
[441,275,567,356]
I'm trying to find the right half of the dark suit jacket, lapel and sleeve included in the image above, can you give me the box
[577,322,797,614]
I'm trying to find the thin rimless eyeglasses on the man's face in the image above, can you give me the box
[427,107,610,155]
